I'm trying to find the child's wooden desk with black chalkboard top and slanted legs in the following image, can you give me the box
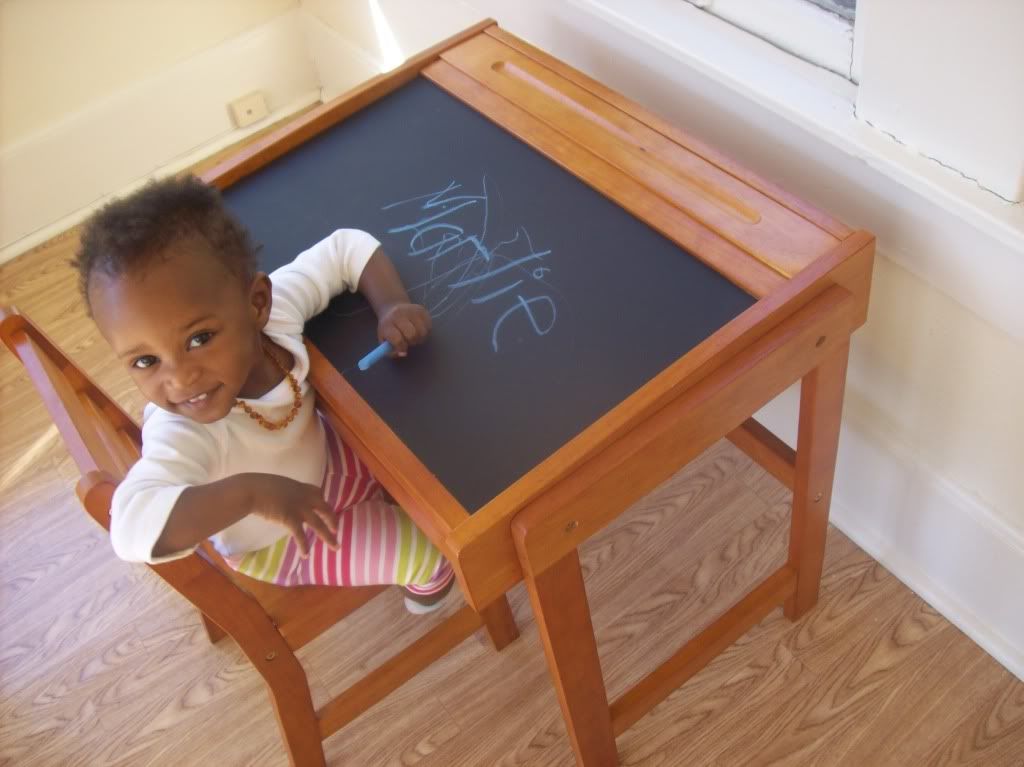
[205,20,874,663]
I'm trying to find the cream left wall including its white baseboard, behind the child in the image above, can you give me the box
[0,0,319,261]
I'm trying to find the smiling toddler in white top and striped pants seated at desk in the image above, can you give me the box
[75,172,453,612]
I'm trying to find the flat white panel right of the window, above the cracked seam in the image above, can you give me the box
[857,0,1024,202]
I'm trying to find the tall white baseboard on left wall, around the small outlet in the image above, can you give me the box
[0,9,319,262]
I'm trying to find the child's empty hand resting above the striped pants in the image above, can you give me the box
[245,474,338,557]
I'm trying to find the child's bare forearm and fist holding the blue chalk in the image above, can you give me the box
[358,248,430,356]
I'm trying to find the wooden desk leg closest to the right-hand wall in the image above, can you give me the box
[783,342,850,621]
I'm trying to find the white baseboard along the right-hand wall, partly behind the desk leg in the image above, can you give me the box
[758,387,1024,680]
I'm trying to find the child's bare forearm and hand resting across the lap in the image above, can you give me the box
[153,473,338,558]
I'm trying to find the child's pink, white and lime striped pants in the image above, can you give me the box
[226,418,454,595]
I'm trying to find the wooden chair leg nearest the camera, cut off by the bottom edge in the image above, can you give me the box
[256,648,327,767]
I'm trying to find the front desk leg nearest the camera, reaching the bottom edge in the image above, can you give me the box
[520,549,618,767]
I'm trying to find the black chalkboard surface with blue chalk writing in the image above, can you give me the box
[225,79,754,512]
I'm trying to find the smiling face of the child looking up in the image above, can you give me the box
[89,244,270,423]
